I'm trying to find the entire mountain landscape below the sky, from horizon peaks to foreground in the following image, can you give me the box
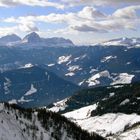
[0,33,140,140]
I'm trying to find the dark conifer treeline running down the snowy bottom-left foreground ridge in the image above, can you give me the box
[4,103,105,140]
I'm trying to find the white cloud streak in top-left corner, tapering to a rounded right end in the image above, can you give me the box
[0,0,64,9]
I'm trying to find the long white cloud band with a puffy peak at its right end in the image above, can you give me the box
[3,6,106,24]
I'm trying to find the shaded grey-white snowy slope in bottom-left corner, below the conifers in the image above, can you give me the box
[0,104,50,140]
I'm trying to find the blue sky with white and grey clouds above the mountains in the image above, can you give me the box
[0,0,140,45]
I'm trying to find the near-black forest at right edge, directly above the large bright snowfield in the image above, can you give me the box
[91,83,140,116]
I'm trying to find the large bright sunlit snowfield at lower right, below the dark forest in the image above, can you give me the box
[63,104,140,140]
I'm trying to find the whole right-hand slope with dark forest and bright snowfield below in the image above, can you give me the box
[50,83,140,140]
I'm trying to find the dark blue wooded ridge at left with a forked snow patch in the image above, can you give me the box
[0,65,79,108]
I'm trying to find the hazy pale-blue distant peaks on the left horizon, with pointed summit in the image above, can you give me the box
[0,32,74,49]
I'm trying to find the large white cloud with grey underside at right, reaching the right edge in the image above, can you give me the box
[69,5,140,33]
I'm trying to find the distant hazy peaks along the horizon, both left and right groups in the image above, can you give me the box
[0,32,140,48]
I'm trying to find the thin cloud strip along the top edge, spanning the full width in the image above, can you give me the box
[0,0,140,9]
